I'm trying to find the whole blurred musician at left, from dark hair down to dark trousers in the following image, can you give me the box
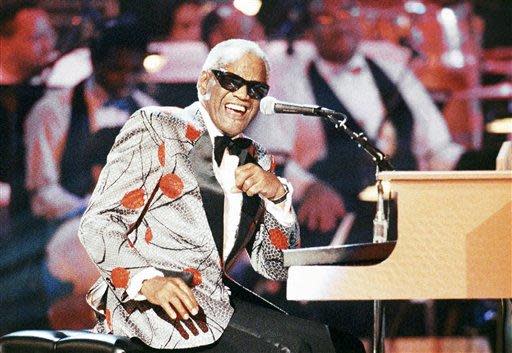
[0,19,156,330]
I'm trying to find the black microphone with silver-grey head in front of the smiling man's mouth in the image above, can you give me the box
[260,96,345,119]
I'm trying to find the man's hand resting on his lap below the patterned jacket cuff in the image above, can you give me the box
[140,277,199,320]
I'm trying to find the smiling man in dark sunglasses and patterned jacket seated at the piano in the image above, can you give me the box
[79,39,362,352]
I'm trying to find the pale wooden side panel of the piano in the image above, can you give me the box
[287,171,512,300]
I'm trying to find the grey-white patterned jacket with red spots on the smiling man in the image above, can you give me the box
[79,102,299,349]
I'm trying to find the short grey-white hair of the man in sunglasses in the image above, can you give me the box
[197,39,270,101]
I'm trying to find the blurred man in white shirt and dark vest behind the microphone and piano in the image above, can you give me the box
[248,0,464,336]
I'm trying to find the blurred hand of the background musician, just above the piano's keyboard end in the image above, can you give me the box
[297,181,345,233]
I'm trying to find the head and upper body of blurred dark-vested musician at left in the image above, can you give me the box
[25,18,156,221]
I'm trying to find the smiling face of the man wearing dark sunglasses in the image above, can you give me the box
[198,53,267,136]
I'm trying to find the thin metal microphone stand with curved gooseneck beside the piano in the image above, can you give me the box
[314,107,394,353]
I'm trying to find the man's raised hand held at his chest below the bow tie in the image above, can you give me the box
[235,163,286,200]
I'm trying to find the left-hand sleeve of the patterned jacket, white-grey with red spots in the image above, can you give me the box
[78,110,165,301]
